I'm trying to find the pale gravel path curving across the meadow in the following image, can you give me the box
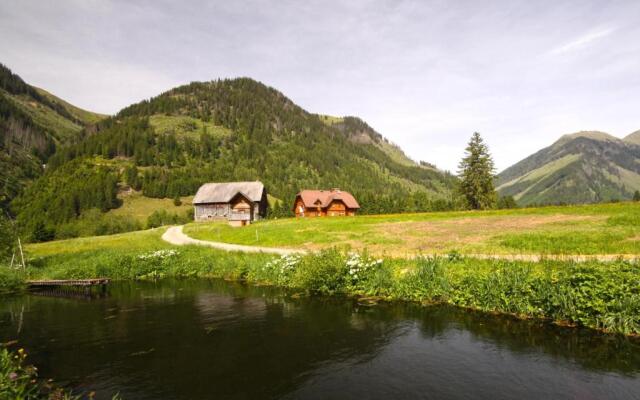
[162,226,640,262]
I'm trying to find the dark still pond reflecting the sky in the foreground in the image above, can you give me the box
[0,280,640,399]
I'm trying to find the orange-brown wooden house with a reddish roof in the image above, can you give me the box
[293,189,360,217]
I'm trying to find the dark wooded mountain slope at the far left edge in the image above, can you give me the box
[0,64,104,211]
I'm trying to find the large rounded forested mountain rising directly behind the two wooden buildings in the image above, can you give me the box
[14,78,456,239]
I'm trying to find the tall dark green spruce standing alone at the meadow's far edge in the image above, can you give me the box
[458,132,497,210]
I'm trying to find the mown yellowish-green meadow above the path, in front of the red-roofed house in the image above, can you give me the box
[184,203,640,257]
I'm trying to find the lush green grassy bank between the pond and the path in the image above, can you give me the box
[0,229,640,335]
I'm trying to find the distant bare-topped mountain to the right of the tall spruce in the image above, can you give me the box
[497,131,640,205]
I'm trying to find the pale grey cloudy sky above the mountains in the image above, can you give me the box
[0,0,640,172]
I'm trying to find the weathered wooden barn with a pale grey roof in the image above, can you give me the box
[193,182,268,226]
